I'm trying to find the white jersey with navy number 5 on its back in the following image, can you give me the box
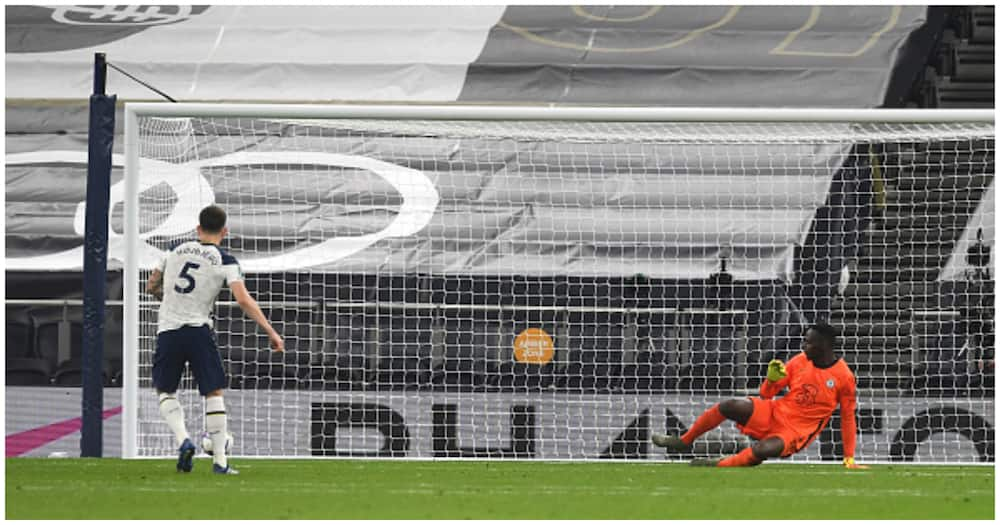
[156,241,243,333]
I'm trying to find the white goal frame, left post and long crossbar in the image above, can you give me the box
[122,102,995,458]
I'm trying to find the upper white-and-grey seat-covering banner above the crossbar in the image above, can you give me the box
[6,5,928,106]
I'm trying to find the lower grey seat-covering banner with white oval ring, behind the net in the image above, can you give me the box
[6,128,852,282]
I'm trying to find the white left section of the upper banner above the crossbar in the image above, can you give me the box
[6,6,504,101]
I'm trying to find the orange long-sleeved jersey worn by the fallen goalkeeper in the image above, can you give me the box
[760,352,857,457]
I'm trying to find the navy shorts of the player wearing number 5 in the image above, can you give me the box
[153,325,226,396]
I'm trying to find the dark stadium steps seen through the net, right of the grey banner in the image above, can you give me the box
[832,133,994,389]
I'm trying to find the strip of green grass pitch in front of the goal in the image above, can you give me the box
[6,457,994,519]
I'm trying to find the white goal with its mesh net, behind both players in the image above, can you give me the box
[123,104,996,462]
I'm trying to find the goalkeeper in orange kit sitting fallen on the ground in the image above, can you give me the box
[653,323,866,468]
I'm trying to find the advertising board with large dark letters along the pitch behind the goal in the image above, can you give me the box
[5,387,995,462]
